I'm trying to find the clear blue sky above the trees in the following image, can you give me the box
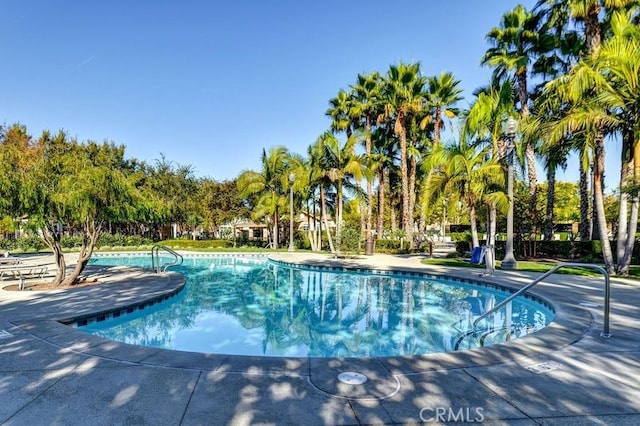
[0,0,611,186]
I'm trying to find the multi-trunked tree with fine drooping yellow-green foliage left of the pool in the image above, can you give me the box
[17,131,154,286]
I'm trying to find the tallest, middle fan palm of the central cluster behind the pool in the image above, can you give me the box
[383,63,426,248]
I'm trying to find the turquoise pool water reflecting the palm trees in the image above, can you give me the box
[80,255,553,357]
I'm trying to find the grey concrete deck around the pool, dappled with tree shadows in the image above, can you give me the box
[0,253,640,425]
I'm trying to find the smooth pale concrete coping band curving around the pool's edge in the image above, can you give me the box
[12,251,594,382]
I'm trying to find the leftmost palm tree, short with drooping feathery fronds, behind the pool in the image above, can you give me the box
[238,146,290,249]
